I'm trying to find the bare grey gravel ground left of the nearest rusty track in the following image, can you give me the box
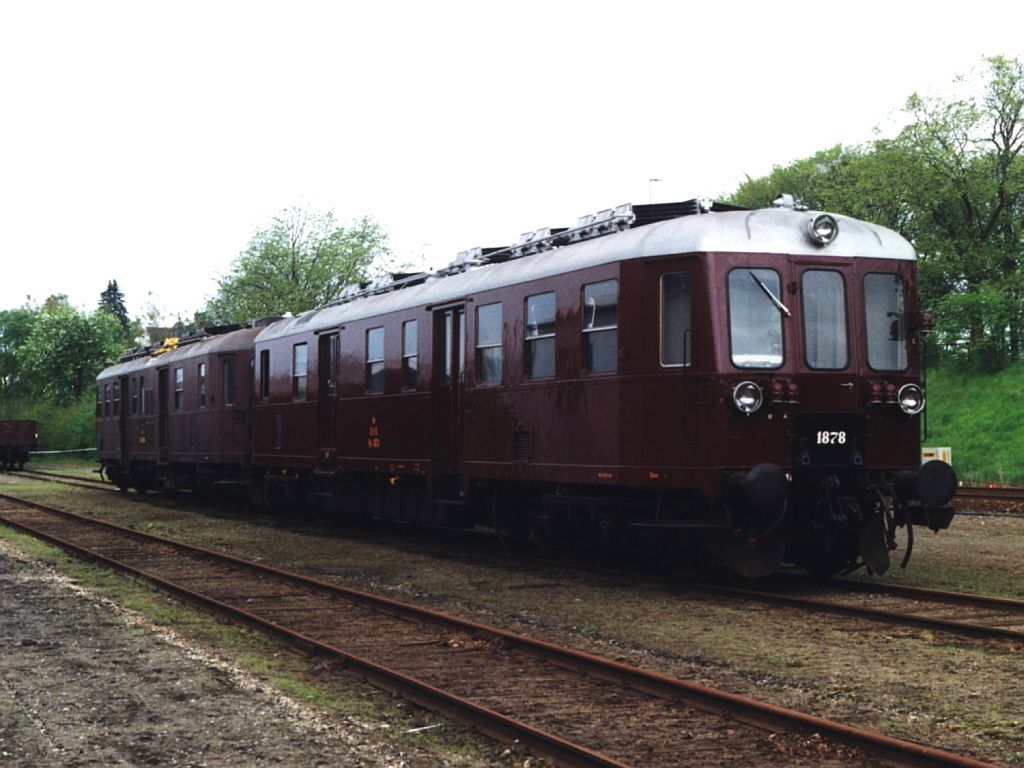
[0,541,497,768]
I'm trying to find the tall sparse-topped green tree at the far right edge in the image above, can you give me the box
[897,56,1024,370]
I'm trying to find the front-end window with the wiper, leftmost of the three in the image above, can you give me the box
[729,267,790,368]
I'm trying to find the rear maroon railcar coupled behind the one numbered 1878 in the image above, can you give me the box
[96,328,259,492]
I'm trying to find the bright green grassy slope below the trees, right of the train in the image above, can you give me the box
[925,362,1024,485]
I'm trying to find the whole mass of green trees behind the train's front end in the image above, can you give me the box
[731,56,1024,370]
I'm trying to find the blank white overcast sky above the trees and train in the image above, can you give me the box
[0,0,1024,319]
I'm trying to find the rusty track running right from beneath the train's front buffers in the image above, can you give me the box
[711,574,1024,643]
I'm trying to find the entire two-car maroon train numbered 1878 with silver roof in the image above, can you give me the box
[96,196,957,577]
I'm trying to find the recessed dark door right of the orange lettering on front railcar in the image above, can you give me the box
[431,304,466,474]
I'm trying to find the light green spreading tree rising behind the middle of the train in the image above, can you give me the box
[197,208,389,323]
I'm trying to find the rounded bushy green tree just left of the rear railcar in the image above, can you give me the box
[15,296,124,406]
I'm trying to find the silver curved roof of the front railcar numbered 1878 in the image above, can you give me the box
[257,209,916,341]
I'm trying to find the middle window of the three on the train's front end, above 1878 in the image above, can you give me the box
[801,269,850,371]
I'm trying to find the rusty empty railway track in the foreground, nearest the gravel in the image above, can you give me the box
[0,497,986,767]
